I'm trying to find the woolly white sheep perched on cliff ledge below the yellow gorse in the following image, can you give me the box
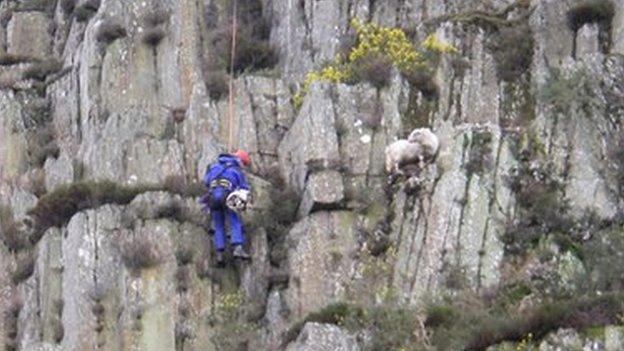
[386,128,440,175]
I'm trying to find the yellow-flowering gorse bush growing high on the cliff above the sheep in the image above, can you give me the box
[293,19,458,108]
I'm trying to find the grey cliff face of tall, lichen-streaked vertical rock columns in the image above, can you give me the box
[0,0,624,350]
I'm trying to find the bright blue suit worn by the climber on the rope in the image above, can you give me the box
[204,154,249,251]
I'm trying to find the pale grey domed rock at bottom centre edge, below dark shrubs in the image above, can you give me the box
[286,323,360,351]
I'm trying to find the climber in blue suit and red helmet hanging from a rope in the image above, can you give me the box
[201,150,251,265]
